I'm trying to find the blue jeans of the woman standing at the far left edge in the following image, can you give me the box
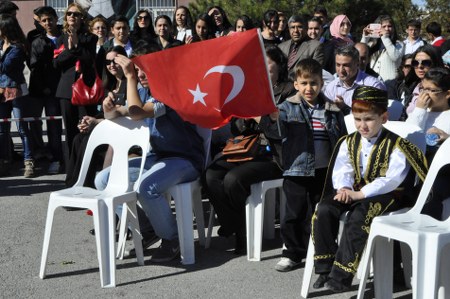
[0,97,33,160]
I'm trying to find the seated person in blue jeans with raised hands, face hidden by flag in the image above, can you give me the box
[95,44,205,262]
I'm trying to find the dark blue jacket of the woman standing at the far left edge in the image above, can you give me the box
[0,41,26,88]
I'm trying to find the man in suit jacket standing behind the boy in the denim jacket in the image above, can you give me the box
[278,15,324,77]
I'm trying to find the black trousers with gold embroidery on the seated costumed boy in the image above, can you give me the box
[312,192,401,286]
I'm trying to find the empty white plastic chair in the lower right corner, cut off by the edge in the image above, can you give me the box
[358,139,450,298]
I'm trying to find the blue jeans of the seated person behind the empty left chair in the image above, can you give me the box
[95,155,200,240]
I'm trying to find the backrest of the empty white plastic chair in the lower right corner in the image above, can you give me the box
[407,138,450,216]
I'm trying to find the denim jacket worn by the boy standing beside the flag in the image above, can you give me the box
[260,94,347,176]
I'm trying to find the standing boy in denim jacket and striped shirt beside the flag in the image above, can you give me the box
[270,58,347,272]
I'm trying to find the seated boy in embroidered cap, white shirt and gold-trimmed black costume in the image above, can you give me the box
[311,86,427,293]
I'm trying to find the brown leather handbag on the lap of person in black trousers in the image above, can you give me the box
[222,134,260,162]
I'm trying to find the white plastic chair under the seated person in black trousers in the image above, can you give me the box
[245,179,286,261]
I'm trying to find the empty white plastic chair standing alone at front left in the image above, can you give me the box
[39,117,150,287]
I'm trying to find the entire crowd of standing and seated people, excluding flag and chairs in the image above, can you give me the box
[0,1,450,292]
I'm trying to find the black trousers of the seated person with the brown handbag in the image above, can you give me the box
[204,159,282,236]
